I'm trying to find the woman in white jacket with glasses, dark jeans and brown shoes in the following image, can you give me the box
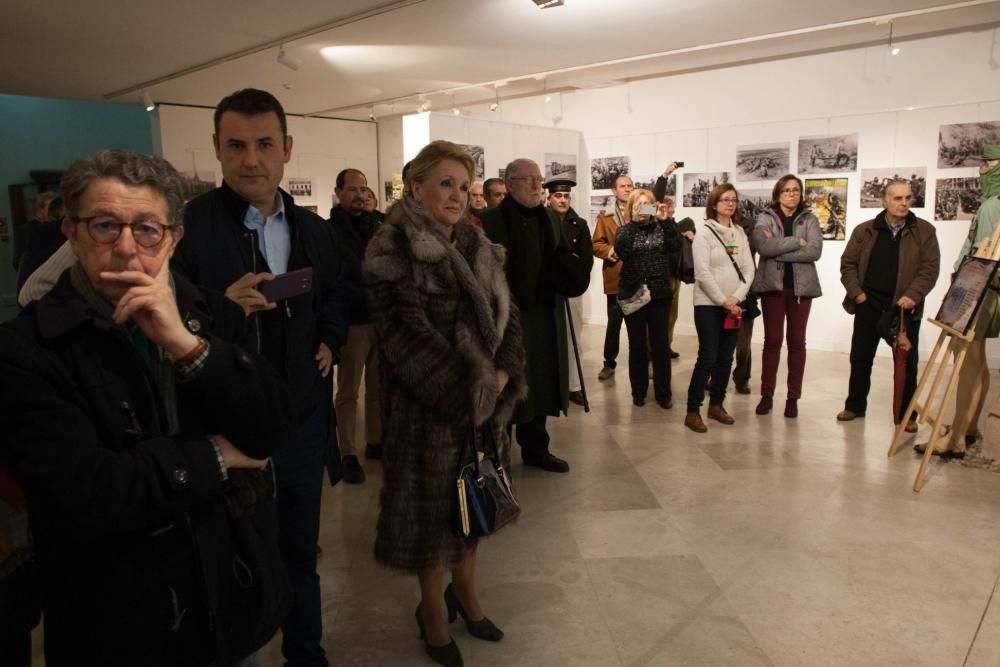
[684,183,754,433]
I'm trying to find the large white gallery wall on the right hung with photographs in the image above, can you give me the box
[464,30,1000,356]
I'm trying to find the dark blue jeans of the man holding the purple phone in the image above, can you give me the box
[272,401,330,667]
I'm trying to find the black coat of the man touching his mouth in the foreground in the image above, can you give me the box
[0,271,291,667]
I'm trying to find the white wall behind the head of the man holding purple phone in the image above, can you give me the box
[153,104,382,218]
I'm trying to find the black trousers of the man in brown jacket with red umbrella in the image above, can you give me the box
[844,299,920,424]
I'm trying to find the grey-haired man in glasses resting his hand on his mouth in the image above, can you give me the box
[0,151,291,665]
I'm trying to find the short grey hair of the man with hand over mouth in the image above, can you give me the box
[59,150,184,225]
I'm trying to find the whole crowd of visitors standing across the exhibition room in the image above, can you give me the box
[0,81,1000,667]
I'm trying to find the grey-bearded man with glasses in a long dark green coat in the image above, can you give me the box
[483,158,593,472]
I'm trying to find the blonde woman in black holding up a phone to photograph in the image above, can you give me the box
[615,189,680,410]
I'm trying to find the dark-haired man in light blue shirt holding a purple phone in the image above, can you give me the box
[173,89,347,665]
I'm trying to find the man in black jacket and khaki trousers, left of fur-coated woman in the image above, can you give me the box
[329,168,382,484]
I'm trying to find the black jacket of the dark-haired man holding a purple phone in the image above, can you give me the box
[176,183,350,419]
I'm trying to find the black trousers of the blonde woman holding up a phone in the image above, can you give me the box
[625,299,671,403]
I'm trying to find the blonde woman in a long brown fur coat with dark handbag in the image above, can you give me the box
[364,141,527,665]
